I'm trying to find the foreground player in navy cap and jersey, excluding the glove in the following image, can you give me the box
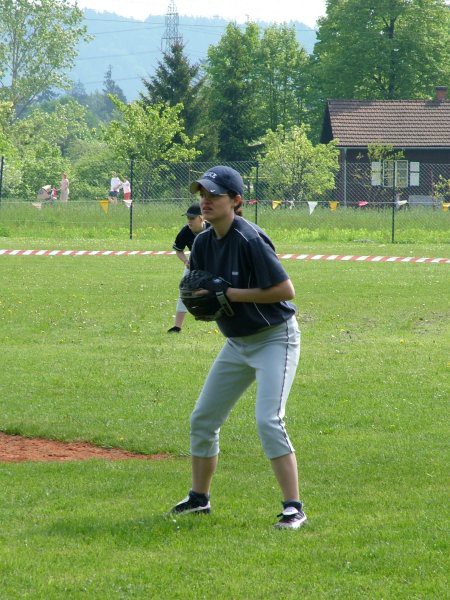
[171,166,306,529]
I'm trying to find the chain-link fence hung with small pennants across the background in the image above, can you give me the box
[0,161,450,243]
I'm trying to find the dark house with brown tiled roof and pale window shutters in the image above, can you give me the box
[320,86,450,206]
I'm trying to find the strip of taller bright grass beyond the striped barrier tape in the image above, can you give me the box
[0,200,450,246]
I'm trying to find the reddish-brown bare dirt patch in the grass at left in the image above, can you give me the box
[0,432,169,462]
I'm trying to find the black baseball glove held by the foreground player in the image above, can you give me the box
[180,270,234,321]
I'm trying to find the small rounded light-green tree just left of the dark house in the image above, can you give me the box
[260,124,339,201]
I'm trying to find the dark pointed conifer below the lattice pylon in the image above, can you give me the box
[140,43,204,135]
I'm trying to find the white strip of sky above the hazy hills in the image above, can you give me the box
[77,0,325,27]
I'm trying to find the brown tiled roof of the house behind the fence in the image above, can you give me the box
[328,100,450,148]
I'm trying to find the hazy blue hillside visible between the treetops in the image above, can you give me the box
[71,10,316,100]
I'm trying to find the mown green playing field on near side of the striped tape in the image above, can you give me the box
[0,251,450,599]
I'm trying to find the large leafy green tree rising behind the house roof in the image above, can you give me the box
[314,0,450,100]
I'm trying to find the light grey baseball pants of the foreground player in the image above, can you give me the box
[191,317,300,459]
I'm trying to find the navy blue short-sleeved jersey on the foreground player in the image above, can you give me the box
[190,216,296,337]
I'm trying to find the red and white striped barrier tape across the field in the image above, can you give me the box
[0,249,450,264]
